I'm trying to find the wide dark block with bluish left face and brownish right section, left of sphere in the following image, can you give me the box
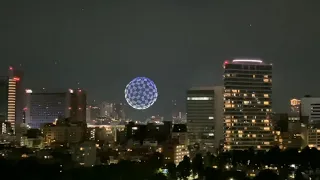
[25,89,86,128]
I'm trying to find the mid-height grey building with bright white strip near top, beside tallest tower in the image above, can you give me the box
[187,87,223,151]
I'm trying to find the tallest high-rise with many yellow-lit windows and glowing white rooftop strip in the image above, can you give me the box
[223,59,274,150]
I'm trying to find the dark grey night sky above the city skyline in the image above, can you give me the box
[0,0,320,120]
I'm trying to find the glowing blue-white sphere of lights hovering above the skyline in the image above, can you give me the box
[124,77,158,110]
